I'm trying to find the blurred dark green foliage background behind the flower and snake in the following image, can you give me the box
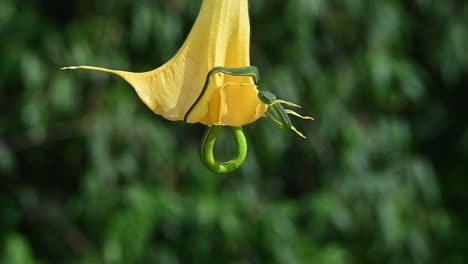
[0,0,468,264]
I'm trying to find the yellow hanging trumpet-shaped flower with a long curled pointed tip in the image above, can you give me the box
[62,0,268,126]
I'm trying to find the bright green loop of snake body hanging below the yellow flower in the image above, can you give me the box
[200,125,247,174]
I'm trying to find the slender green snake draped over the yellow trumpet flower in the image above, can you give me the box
[184,66,292,174]
